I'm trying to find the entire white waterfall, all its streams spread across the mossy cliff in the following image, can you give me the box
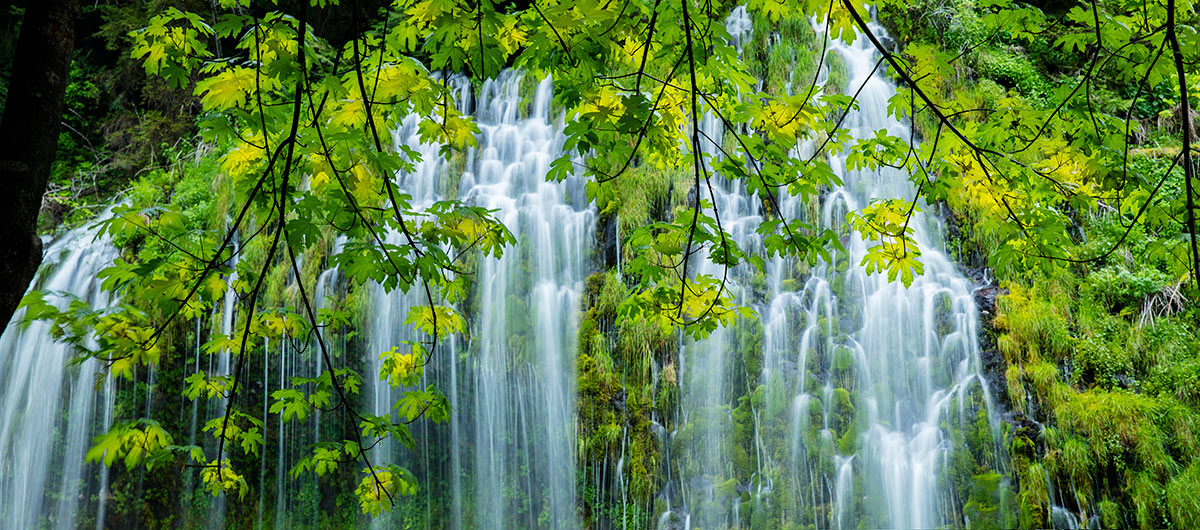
[0,7,1000,529]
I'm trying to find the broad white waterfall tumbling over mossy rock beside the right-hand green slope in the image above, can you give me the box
[661,8,998,529]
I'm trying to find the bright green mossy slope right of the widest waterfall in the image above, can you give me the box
[882,2,1200,528]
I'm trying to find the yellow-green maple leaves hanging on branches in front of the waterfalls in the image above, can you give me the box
[18,0,1200,514]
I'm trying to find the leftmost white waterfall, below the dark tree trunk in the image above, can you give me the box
[0,217,116,529]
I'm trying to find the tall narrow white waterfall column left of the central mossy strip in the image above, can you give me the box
[367,72,594,529]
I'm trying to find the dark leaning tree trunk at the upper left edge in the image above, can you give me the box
[0,0,79,329]
